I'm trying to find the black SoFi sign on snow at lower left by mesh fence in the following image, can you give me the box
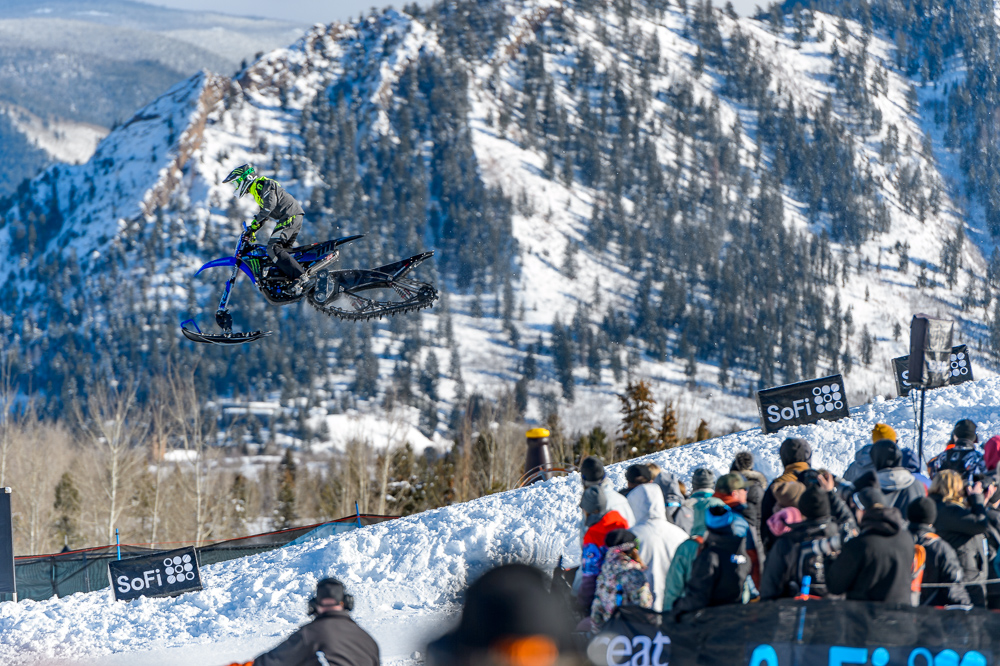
[108,546,201,601]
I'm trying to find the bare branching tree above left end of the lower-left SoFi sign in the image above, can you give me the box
[74,382,149,543]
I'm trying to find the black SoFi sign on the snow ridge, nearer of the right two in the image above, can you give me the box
[757,375,850,433]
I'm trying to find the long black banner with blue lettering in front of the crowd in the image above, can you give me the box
[587,599,1000,666]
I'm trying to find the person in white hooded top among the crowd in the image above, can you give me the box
[628,483,687,613]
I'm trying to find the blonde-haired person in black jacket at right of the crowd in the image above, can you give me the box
[930,469,990,607]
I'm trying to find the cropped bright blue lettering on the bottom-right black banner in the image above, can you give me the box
[749,645,989,666]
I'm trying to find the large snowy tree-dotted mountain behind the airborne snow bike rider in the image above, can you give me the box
[0,0,1000,444]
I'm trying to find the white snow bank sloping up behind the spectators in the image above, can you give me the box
[0,378,1000,666]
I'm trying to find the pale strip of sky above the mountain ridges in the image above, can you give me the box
[147,0,767,23]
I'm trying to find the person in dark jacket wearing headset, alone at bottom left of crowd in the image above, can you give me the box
[253,578,379,666]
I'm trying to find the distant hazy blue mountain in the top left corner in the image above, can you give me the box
[0,0,304,196]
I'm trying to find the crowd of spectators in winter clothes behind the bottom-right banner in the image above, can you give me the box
[573,419,1000,632]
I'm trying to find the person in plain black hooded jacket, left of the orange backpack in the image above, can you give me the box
[826,486,913,606]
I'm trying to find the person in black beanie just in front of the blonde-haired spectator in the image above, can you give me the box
[906,497,972,606]
